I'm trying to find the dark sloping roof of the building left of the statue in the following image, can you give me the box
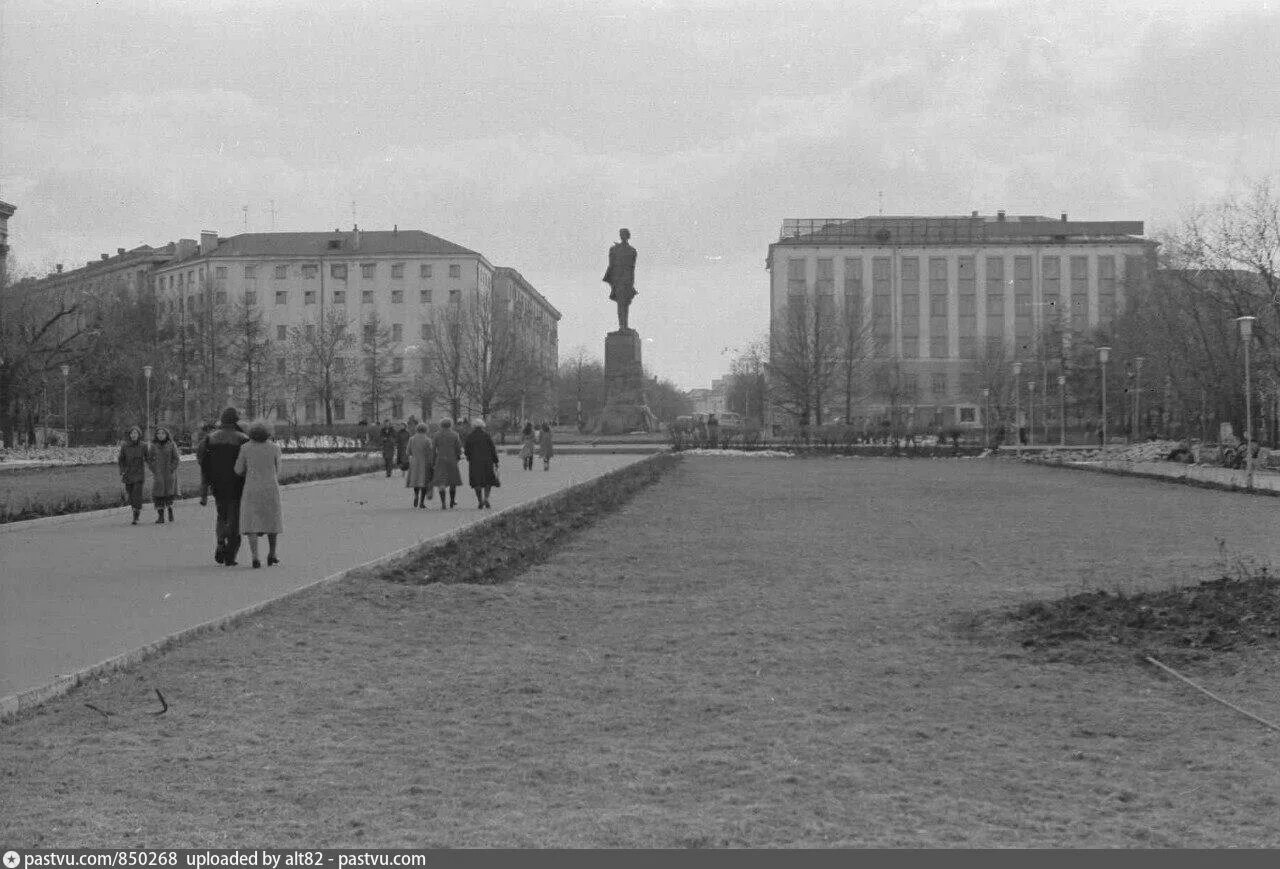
[189,229,480,259]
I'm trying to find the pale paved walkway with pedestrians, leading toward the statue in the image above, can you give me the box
[0,454,643,699]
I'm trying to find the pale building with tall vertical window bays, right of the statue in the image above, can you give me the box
[765,211,1156,427]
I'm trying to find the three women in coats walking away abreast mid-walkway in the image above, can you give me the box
[404,417,499,509]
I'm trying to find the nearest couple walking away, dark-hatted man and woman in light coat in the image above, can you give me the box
[196,407,284,567]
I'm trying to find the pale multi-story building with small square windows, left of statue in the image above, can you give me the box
[154,228,559,422]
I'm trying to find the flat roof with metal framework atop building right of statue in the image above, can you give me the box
[776,211,1153,246]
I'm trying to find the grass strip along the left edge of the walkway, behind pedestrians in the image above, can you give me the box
[0,456,381,523]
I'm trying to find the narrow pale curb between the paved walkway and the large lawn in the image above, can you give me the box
[0,450,678,724]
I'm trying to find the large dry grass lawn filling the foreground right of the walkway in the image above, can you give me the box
[0,458,1280,847]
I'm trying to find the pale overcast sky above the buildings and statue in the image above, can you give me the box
[0,0,1280,388]
